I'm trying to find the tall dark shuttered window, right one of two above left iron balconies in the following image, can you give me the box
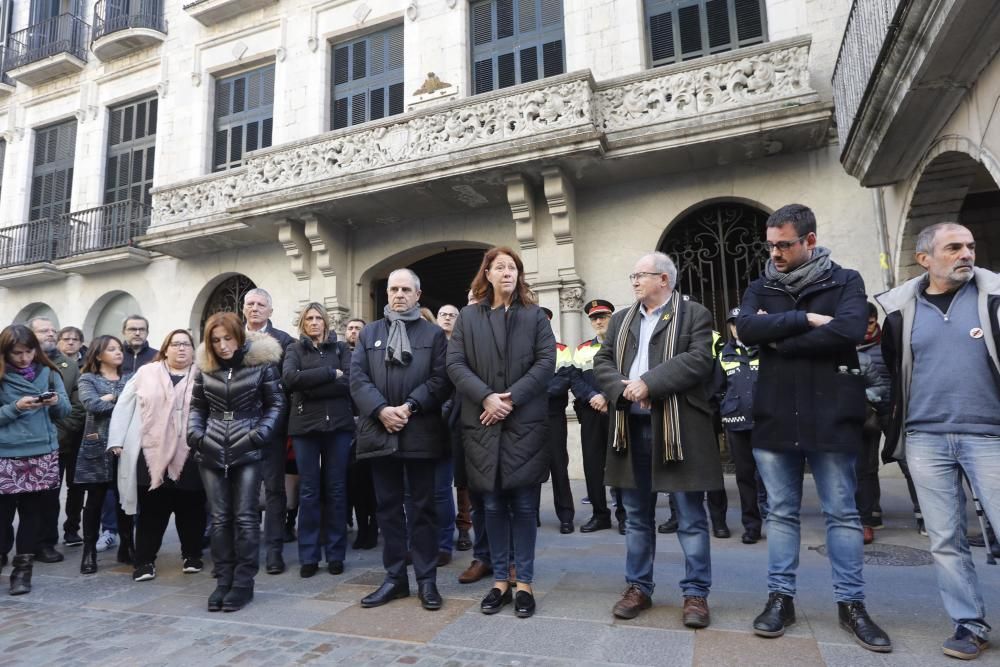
[104,96,157,205]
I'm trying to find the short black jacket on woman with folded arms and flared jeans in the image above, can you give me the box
[281,332,354,435]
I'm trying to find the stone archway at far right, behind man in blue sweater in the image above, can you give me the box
[895,135,1000,282]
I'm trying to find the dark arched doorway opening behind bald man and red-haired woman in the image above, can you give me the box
[371,248,485,319]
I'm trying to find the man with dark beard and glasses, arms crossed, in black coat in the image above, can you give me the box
[736,204,892,652]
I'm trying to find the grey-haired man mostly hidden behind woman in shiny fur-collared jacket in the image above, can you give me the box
[243,287,295,574]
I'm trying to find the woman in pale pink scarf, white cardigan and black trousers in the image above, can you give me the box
[108,329,205,581]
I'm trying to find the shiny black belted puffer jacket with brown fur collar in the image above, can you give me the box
[188,333,286,472]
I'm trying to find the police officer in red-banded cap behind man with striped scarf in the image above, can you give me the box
[573,299,625,533]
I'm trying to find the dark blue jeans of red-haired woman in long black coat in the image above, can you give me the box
[483,484,541,584]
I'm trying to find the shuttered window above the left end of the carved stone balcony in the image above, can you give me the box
[212,65,274,171]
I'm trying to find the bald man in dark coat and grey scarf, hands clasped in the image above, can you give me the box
[351,269,452,610]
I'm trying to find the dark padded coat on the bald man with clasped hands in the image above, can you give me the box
[350,319,452,459]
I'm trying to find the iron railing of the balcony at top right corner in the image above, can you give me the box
[833,0,907,150]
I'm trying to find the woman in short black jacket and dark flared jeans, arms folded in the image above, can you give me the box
[281,303,354,577]
